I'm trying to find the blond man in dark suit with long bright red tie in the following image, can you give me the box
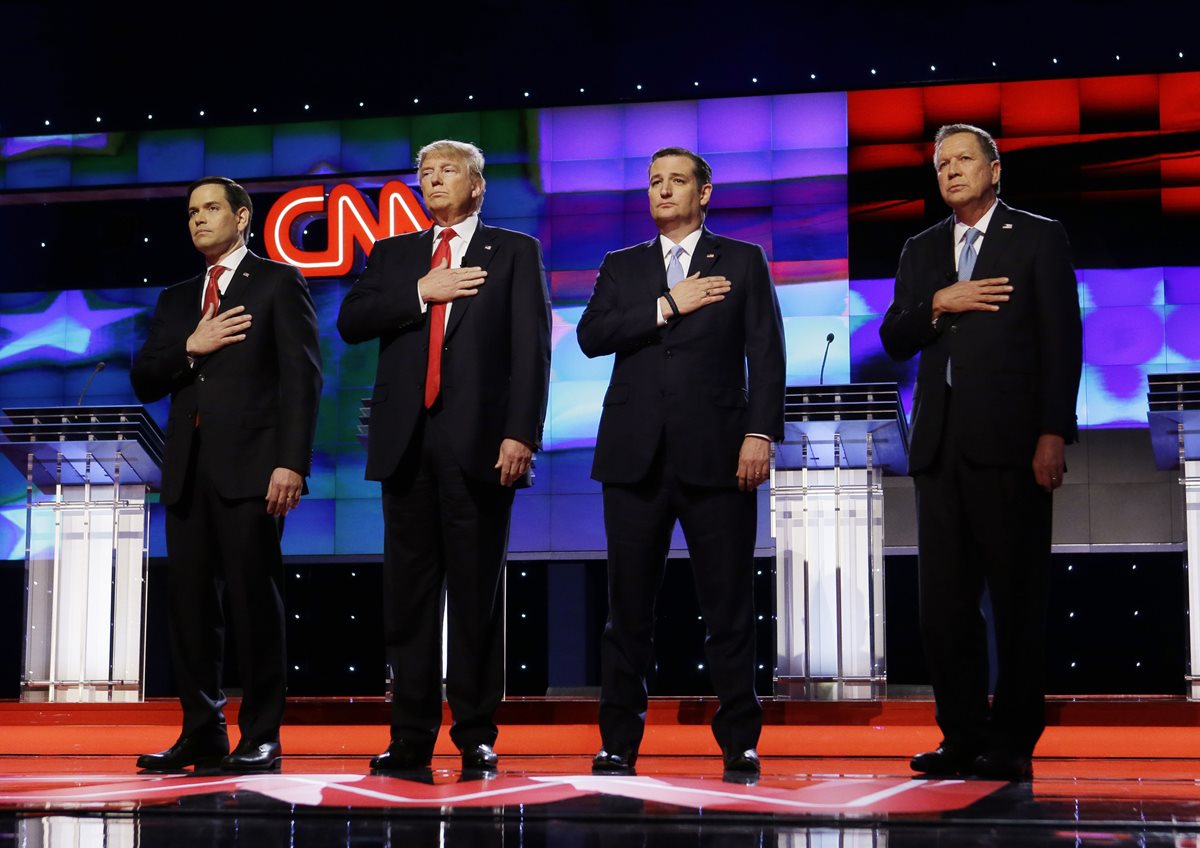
[337,140,550,771]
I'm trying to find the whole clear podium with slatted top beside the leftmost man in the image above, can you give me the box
[0,405,163,702]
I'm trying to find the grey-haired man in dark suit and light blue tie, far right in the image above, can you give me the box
[880,124,1082,780]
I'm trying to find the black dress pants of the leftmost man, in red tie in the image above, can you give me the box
[167,427,287,745]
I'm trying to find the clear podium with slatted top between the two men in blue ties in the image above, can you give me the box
[772,383,908,699]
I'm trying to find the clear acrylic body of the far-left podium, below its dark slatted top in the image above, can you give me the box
[20,443,149,700]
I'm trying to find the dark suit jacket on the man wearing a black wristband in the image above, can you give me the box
[578,229,786,487]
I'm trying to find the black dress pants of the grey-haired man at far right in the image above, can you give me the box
[916,389,1052,756]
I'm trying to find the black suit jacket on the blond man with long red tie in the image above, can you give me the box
[337,221,550,486]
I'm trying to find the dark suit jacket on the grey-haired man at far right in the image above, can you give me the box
[880,202,1082,474]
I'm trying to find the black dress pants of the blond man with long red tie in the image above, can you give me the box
[383,405,515,751]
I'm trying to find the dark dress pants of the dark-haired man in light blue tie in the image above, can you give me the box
[600,445,762,753]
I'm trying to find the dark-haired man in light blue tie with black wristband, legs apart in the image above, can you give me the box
[578,148,786,775]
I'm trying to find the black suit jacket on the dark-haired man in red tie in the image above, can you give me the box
[130,253,322,505]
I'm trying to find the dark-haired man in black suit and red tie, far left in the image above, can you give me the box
[130,176,322,771]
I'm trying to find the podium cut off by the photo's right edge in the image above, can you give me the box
[1146,372,1200,700]
